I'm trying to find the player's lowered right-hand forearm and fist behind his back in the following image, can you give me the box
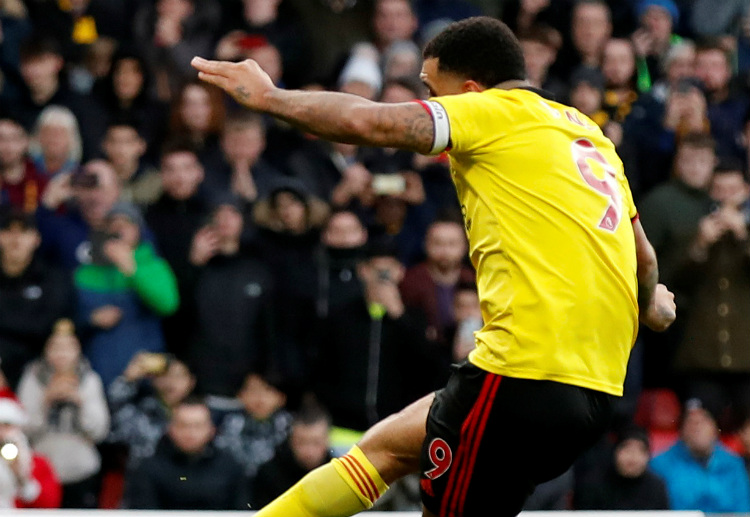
[633,219,677,332]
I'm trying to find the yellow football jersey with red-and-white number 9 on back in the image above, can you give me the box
[423,88,638,395]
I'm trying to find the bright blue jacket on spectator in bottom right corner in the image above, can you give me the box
[651,440,750,513]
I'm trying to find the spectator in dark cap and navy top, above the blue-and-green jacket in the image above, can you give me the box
[36,160,120,271]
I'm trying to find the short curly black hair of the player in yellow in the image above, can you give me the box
[423,16,526,88]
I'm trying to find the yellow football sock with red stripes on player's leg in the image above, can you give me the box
[256,445,388,517]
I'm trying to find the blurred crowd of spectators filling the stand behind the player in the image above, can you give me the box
[0,0,750,513]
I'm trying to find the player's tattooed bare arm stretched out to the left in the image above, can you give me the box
[192,57,434,154]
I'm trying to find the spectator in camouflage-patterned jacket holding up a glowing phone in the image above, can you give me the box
[107,352,195,472]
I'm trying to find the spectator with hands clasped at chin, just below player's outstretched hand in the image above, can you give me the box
[206,112,281,203]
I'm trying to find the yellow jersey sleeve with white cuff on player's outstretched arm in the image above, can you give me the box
[419,92,506,154]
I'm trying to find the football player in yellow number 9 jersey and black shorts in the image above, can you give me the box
[193,17,675,517]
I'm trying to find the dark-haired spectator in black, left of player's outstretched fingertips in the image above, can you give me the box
[93,47,167,160]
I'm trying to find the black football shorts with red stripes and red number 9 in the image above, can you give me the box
[420,361,616,517]
